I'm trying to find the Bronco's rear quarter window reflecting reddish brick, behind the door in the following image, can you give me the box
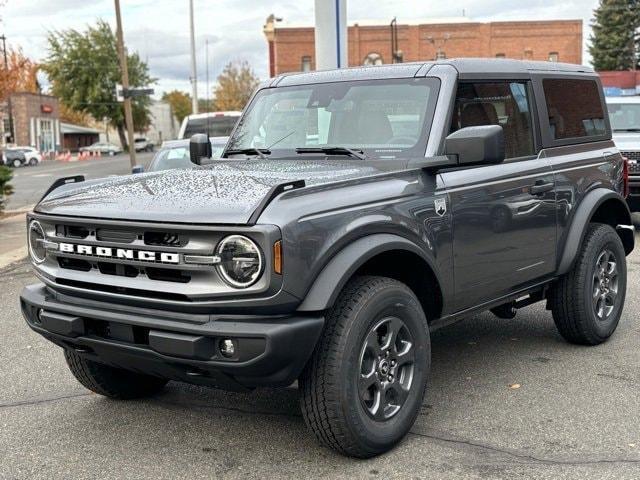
[542,78,607,140]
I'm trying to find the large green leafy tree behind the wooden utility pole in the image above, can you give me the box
[42,20,155,146]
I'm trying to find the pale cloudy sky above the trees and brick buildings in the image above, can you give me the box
[0,0,598,98]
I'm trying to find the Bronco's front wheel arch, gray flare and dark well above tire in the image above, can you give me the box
[298,234,443,321]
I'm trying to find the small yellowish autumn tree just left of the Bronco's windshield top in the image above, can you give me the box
[213,61,260,110]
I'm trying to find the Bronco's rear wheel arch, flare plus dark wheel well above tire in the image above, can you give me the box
[557,188,635,275]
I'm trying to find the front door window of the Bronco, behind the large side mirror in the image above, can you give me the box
[451,82,535,158]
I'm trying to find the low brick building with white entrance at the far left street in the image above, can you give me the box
[5,93,61,152]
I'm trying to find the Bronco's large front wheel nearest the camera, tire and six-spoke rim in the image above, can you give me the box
[299,276,431,458]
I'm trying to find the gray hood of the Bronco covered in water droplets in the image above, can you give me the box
[35,159,384,224]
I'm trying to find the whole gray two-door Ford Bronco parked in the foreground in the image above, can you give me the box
[21,59,634,457]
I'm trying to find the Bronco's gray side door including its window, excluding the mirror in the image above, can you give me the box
[442,81,556,310]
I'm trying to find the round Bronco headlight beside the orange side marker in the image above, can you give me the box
[216,235,264,288]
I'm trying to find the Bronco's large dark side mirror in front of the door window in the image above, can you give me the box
[444,125,504,166]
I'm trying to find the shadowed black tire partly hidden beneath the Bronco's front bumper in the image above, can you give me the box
[64,349,167,400]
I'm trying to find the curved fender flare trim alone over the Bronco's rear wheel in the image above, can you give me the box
[557,188,634,275]
